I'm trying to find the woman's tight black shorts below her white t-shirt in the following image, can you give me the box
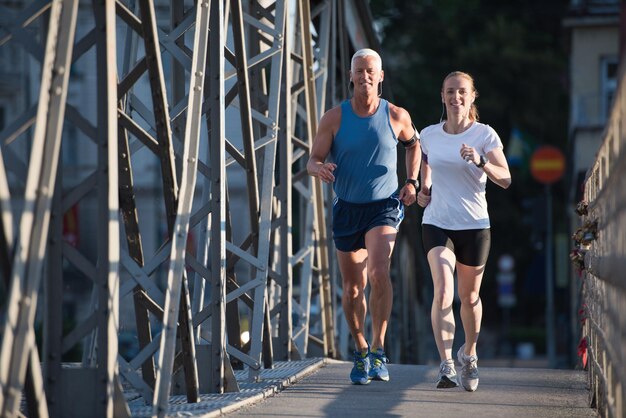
[422,224,491,267]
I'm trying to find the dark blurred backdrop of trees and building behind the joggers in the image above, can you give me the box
[370,0,623,367]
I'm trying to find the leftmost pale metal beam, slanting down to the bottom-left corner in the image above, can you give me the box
[0,0,78,416]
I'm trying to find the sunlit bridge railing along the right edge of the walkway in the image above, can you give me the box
[574,53,626,417]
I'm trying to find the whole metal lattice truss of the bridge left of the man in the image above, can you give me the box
[0,0,382,417]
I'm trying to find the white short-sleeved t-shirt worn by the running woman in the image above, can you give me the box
[420,122,502,230]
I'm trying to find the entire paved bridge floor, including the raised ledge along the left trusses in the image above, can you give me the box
[125,359,597,418]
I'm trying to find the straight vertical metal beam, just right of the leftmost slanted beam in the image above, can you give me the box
[93,0,121,417]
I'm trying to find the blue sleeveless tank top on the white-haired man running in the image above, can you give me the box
[330,99,398,203]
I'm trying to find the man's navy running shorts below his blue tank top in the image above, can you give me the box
[333,193,404,252]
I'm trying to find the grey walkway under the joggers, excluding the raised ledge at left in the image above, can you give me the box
[228,360,597,418]
